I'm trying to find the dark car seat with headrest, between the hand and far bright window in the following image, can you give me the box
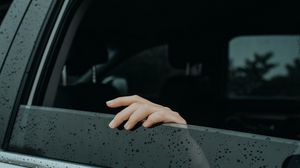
[160,41,226,127]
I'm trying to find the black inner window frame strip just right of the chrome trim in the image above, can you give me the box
[35,0,91,106]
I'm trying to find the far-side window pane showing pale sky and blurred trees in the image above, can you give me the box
[228,35,300,98]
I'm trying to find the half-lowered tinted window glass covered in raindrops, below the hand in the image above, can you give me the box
[9,106,299,168]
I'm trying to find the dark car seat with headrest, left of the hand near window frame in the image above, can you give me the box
[54,20,119,113]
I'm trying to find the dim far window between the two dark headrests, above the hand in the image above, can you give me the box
[102,44,184,98]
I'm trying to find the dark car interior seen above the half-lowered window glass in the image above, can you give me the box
[37,0,300,139]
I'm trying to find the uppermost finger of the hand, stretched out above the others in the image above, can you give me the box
[106,95,149,108]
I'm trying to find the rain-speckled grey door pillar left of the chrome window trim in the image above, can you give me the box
[0,0,63,150]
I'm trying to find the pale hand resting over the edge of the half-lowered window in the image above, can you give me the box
[106,95,186,130]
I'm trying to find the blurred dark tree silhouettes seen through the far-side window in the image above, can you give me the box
[229,52,300,97]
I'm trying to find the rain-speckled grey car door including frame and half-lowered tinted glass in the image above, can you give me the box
[0,0,300,168]
